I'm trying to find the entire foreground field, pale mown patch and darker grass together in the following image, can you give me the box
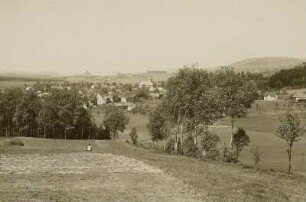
[0,138,306,201]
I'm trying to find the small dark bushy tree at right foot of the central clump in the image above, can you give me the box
[231,128,250,162]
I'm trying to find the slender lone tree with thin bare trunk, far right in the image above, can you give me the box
[275,108,303,173]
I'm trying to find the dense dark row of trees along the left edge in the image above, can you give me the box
[0,88,97,139]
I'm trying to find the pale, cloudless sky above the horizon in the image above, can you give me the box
[0,0,306,75]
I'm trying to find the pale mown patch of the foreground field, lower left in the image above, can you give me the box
[0,152,195,201]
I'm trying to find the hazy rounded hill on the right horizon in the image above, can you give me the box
[230,57,305,75]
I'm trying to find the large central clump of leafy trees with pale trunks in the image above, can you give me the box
[148,65,258,160]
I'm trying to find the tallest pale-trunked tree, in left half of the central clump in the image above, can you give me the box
[163,64,216,154]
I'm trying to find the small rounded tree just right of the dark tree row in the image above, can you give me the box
[103,106,129,139]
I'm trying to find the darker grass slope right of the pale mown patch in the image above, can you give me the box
[96,142,306,201]
